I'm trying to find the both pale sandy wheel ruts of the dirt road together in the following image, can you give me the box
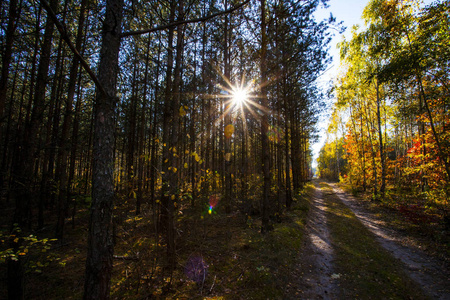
[289,182,450,300]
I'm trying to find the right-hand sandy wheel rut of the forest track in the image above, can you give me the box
[329,184,450,300]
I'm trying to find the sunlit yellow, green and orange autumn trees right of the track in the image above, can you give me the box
[318,1,450,228]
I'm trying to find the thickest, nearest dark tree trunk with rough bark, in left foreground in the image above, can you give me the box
[83,0,123,299]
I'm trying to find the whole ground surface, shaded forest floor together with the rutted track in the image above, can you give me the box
[0,180,450,299]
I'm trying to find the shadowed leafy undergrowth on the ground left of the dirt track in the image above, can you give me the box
[1,186,309,299]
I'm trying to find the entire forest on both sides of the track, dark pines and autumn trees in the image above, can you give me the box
[0,0,450,299]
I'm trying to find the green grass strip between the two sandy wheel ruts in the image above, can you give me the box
[321,184,426,299]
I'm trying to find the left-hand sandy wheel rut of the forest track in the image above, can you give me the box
[286,185,338,299]
